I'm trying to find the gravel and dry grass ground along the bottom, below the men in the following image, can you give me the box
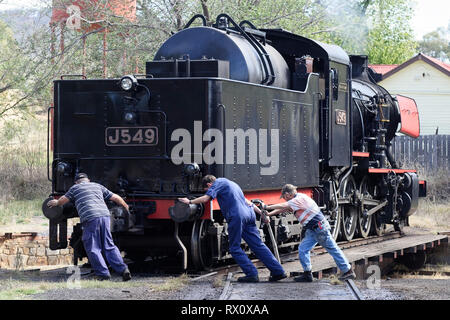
[0,228,450,300]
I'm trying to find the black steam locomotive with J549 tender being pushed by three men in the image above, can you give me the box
[44,14,426,269]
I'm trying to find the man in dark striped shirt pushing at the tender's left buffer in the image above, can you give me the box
[47,173,131,281]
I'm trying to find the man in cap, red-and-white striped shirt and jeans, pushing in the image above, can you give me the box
[264,184,355,282]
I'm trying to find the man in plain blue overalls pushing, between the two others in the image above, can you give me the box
[178,175,287,282]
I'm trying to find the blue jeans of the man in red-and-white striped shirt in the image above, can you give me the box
[298,219,351,272]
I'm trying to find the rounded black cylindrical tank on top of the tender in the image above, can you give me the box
[153,27,290,88]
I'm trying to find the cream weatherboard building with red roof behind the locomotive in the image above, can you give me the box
[370,53,450,135]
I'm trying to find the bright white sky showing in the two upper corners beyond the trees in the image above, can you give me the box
[0,0,450,40]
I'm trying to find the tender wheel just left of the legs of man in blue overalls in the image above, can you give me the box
[191,220,213,270]
